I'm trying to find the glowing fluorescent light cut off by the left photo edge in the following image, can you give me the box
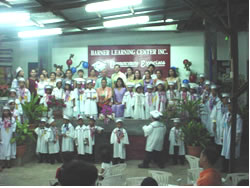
[0,12,30,24]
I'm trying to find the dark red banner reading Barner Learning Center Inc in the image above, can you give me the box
[88,45,170,77]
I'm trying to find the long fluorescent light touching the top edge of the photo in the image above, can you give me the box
[85,0,142,12]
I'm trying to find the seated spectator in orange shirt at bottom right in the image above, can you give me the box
[196,148,222,186]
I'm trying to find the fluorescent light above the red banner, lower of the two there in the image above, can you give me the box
[103,16,149,27]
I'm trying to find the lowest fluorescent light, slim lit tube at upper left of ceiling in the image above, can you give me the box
[18,28,62,38]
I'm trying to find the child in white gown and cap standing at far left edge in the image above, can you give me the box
[0,106,16,168]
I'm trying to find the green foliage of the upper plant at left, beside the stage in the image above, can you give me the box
[22,94,47,124]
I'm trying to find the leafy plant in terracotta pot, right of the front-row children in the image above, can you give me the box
[182,120,210,157]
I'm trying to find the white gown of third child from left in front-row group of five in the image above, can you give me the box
[61,123,75,152]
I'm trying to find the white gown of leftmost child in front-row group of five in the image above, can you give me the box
[35,127,48,154]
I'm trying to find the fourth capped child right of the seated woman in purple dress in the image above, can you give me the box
[155,80,167,113]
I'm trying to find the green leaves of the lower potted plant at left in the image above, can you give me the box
[10,121,35,146]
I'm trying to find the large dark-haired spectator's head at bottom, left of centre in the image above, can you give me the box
[61,160,98,186]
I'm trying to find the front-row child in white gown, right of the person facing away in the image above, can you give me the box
[169,118,185,165]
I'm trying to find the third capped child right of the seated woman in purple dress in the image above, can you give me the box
[145,84,155,119]
